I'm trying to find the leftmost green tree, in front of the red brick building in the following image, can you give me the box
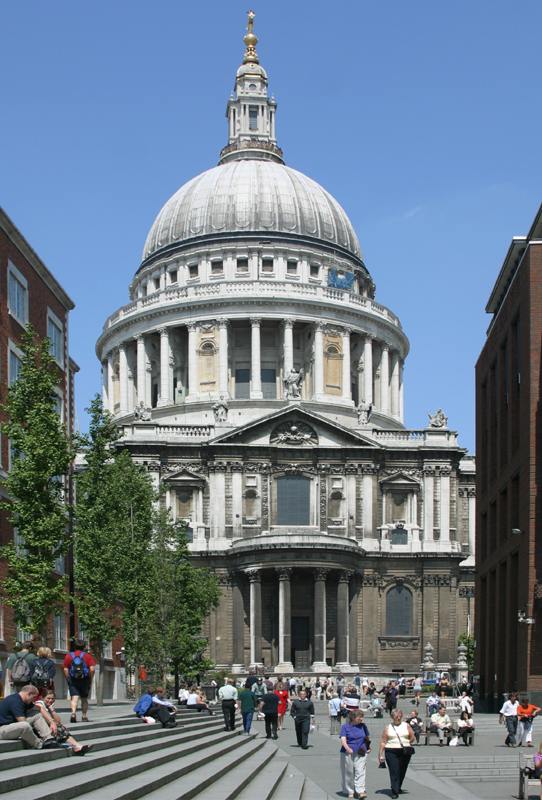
[0,327,74,637]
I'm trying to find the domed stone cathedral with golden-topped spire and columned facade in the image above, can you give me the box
[96,12,475,674]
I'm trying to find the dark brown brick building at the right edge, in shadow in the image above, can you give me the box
[476,206,542,706]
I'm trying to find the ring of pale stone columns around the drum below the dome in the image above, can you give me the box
[102,317,403,421]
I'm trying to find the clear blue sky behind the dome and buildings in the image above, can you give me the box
[0,0,542,449]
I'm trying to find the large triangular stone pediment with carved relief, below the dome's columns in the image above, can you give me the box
[209,405,382,450]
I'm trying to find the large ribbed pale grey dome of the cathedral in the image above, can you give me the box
[143,159,361,260]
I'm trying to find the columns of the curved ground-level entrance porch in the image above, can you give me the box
[232,567,357,672]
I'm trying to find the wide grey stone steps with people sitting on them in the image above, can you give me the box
[0,709,329,800]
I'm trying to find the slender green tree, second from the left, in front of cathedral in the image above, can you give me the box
[74,396,153,703]
